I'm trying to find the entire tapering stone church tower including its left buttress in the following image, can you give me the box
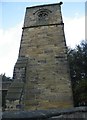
[6,2,73,110]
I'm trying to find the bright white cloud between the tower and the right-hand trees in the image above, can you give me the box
[63,16,85,48]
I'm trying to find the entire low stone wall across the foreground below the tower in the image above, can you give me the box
[2,107,87,120]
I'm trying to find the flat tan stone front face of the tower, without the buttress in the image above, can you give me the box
[22,4,73,110]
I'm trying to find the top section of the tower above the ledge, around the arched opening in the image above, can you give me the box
[24,4,62,27]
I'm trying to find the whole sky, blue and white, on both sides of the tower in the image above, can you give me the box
[0,0,87,77]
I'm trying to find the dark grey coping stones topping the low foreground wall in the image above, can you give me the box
[2,107,87,120]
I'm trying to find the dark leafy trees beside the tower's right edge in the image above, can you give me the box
[68,41,87,106]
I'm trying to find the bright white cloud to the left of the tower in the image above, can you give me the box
[0,22,23,76]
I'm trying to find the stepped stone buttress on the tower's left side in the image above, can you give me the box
[6,56,27,111]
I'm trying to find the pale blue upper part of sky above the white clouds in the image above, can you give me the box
[2,2,85,29]
